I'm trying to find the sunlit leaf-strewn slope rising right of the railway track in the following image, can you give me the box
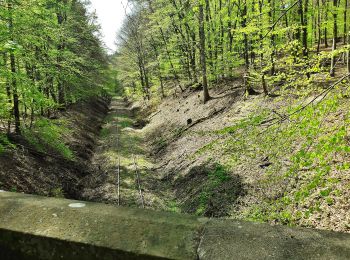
[136,76,350,232]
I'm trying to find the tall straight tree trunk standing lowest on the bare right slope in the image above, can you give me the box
[199,3,210,103]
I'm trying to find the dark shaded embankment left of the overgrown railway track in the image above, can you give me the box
[0,98,108,199]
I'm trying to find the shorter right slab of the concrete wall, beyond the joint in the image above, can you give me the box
[198,220,350,260]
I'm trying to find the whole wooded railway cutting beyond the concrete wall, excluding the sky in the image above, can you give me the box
[0,0,350,238]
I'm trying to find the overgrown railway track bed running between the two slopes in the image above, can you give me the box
[83,97,167,209]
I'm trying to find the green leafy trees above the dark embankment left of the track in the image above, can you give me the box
[0,0,112,139]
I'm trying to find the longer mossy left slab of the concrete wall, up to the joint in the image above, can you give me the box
[0,192,202,259]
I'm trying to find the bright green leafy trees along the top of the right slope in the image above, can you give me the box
[115,0,349,99]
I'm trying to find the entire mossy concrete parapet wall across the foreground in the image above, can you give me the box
[0,192,350,260]
